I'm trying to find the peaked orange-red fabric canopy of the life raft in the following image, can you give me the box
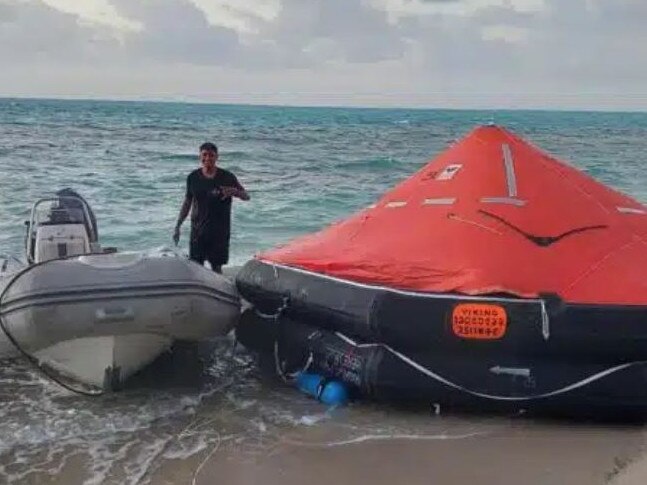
[258,126,647,305]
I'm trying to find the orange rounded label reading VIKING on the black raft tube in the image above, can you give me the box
[452,303,508,340]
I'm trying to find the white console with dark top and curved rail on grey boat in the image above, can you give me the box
[26,189,101,263]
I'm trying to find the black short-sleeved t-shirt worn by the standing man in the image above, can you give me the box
[186,168,242,246]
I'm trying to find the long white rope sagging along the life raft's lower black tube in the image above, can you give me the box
[335,332,647,401]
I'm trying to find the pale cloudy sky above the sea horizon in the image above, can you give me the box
[0,0,647,111]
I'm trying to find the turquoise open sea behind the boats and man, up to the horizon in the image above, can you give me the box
[0,99,647,263]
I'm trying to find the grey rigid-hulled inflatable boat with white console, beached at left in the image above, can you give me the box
[0,192,240,390]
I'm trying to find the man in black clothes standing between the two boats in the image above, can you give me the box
[173,143,249,273]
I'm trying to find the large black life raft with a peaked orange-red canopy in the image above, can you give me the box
[237,126,647,412]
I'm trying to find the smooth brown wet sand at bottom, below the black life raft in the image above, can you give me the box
[146,412,647,485]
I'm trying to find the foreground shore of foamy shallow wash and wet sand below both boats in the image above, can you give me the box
[0,342,647,485]
